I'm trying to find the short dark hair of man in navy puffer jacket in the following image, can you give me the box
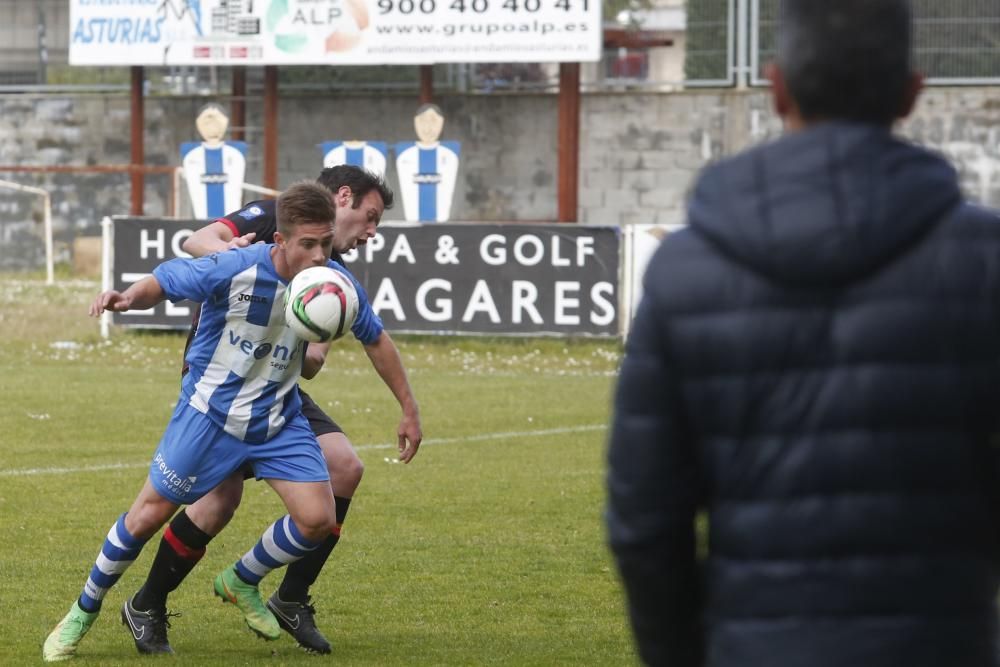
[778,0,912,125]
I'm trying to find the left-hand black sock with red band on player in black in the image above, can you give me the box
[132,510,212,611]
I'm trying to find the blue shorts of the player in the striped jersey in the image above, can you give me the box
[149,398,330,505]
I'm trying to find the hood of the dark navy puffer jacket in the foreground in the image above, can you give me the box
[689,123,961,287]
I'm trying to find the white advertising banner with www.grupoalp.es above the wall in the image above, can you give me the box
[69,0,602,66]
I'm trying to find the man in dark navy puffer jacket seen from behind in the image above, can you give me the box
[607,0,1000,667]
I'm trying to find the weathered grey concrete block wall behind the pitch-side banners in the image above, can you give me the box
[0,88,1000,269]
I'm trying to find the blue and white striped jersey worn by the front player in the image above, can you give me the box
[153,243,382,443]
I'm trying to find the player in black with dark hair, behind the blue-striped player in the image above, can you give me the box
[122,166,423,653]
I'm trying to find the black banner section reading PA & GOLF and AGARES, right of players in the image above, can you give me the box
[345,223,620,336]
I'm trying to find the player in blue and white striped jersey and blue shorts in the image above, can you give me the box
[42,183,410,661]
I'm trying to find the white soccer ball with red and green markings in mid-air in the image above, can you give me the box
[285,266,358,343]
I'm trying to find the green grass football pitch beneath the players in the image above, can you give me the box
[0,276,635,666]
